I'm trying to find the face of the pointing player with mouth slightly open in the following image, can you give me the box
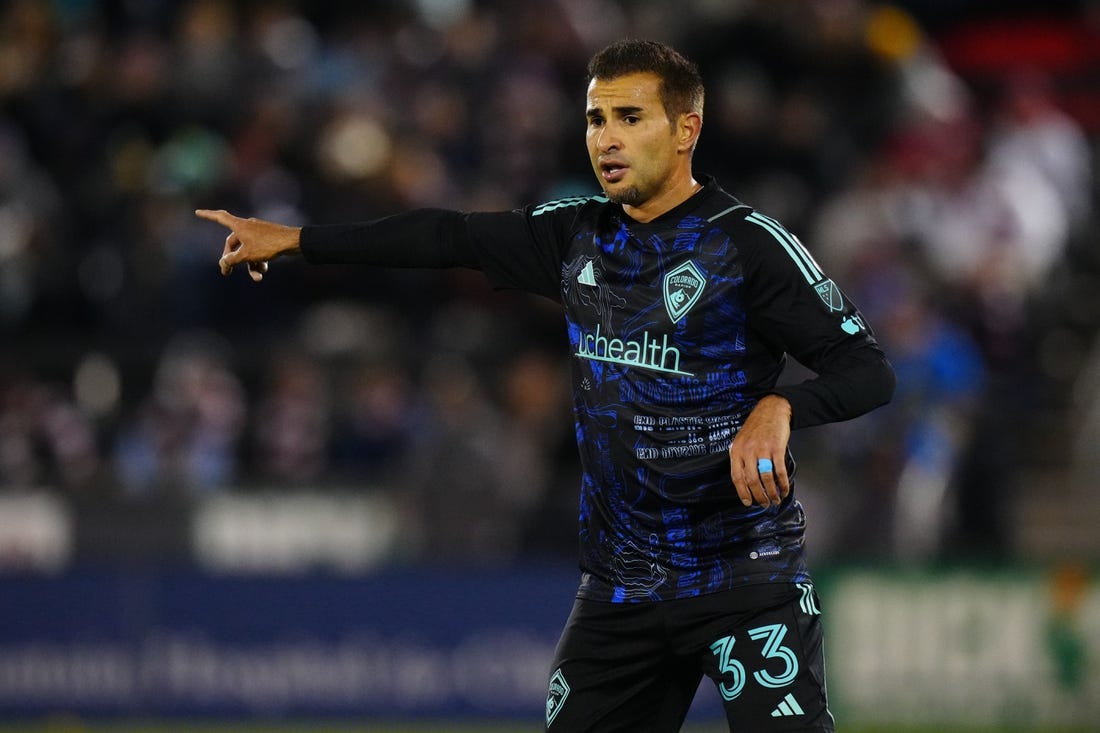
[586,73,679,207]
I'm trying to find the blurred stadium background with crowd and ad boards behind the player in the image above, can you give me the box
[0,0,1100,730]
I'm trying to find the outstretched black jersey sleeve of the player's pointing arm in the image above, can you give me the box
[301,207,572,299]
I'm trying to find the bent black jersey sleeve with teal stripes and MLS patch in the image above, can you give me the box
[739,211,895,428]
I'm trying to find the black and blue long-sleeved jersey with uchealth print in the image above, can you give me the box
[301,177,894,602]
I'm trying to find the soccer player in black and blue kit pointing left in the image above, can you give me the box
[197,41,894,733]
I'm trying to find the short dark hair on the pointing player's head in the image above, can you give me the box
[585,40,703,121]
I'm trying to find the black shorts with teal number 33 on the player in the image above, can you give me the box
[546,582,835,733]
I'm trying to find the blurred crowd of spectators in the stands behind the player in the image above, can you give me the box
[0,0,1100,559]
